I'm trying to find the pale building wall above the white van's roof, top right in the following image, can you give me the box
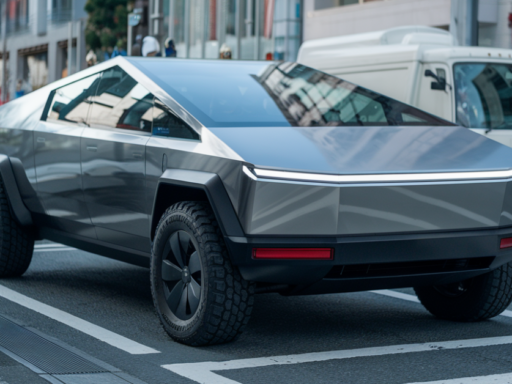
[303,0,512,48]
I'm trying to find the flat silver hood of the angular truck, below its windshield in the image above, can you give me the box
[209,126,512,174]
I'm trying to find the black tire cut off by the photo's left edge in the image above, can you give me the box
[0,178,34,278]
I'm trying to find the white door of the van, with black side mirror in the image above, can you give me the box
[414,63,454,121]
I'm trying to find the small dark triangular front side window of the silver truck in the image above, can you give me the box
[153,99,199,140]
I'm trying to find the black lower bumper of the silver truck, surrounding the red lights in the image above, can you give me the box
[225,227,512,294]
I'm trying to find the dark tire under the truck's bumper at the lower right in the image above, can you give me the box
[414,264,512,322]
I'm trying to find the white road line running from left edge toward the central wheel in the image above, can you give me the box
[0,285,160,355]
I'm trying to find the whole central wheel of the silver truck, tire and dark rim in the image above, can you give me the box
[151,202,254,346]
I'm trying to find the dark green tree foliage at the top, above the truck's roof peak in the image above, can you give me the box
[85,0,132,51]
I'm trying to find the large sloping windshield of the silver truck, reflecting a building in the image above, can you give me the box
[132,59,452,127]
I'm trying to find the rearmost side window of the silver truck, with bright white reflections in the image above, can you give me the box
[46,74,101,123]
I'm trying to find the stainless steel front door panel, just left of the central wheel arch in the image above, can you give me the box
[79,127,150,252]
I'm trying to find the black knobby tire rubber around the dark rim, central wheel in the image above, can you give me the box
[150,202,255,346]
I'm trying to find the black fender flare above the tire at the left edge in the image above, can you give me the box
[0,155,34,227]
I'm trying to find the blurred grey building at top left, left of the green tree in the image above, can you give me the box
[0,0,87,99]
